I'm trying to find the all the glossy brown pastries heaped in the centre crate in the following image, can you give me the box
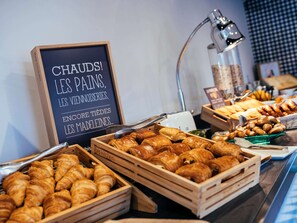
[108,127,244,183]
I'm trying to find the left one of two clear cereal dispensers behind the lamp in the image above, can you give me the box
[207,44,234,99]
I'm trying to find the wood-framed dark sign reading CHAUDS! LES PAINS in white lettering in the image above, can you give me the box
[31,42,124,146]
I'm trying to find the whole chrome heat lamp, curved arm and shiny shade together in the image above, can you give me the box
[176,9,245,111]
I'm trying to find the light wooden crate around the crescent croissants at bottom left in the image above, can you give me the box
[1,144,131,223]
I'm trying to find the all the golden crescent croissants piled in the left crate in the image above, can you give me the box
[0,153,116,223]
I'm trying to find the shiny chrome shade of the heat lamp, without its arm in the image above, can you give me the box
[208,9,245,53]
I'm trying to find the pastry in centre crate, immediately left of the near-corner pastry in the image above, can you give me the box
[149,151,182,172]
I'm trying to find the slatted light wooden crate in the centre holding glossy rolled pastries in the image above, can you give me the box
[91,125,260,218]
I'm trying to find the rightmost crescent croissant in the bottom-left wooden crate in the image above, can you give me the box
[94,164,116,196]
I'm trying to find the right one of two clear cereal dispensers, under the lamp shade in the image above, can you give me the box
[226,46,245,95]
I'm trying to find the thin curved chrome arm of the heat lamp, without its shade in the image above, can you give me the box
[176,17,210,111]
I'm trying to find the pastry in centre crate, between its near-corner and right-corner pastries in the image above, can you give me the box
[208,156,239,175]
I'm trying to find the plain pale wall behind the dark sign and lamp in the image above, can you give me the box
[0,0,253,162]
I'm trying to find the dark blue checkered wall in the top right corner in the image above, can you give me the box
[244,0,297,76]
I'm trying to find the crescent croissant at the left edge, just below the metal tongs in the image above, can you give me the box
[2,171,30,207]
